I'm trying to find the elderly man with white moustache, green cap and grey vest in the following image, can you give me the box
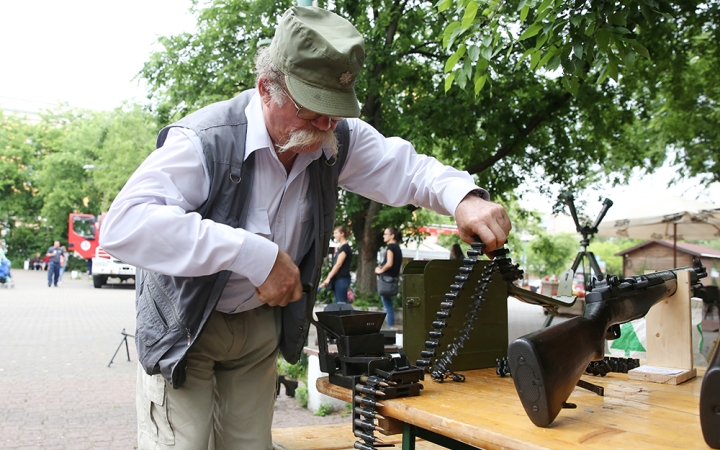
[101,7,511,450]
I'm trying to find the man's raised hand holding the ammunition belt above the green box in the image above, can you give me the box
[455,193,512,252]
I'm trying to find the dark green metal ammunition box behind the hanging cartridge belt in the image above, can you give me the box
[402,260,508,371]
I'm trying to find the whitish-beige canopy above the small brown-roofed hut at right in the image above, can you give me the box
[597,193,720,241]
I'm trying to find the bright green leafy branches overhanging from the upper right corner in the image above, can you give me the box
[438,0,720,183]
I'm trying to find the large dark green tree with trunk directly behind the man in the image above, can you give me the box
[140,0,716,291]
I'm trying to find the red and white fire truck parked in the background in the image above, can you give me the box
[68,213,135,289]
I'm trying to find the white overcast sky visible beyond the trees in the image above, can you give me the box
[0,0,720,216]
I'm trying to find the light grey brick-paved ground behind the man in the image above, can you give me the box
[0,270,349,450]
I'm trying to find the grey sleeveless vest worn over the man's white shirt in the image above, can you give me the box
[135,89,349,388]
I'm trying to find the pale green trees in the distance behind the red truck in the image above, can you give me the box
[0,105,157,261]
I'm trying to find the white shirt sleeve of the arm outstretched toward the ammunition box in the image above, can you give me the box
[339,119,490,216]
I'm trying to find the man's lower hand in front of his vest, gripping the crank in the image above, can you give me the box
[255,251,302,306]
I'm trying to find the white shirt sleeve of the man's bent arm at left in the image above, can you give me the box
[100,128,278,286]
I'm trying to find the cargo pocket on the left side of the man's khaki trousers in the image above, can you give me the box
[137,366,175,450]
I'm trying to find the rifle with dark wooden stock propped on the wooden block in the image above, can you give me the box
[508,260,707,427]
